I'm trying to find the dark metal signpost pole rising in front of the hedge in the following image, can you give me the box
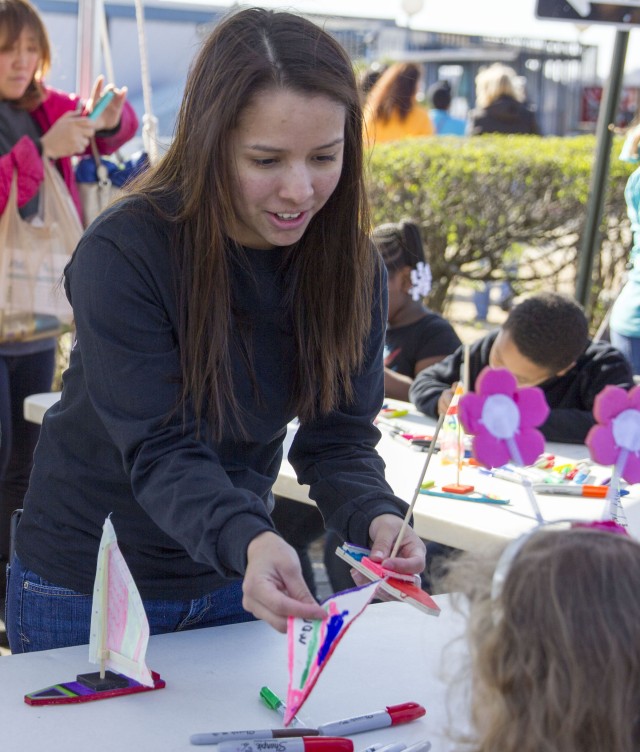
[576,29,629,309]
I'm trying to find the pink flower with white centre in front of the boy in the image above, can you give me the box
[458,367,549,467]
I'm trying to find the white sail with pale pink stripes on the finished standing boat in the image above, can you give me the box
[89,517,153,687]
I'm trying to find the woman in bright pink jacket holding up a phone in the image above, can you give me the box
[0,0,138,600]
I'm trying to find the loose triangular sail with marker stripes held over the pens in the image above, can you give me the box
[284,582,378,726]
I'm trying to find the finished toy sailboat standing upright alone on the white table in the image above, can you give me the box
[24,517,165,705]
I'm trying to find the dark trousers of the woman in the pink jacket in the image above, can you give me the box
[0,348,56,568]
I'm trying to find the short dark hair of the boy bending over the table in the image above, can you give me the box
[502,292,589,373]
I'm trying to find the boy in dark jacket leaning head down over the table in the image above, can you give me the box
[409,293,633,444]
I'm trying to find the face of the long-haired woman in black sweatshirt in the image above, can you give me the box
[228,89,346,249]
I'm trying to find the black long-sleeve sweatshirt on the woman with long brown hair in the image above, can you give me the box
[17,200,406,599]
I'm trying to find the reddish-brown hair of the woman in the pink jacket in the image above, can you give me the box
[0,0,51,110]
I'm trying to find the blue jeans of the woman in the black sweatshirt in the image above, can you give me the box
[6,555,255,653]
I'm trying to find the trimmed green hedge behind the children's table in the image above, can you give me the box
[368,135,633,326]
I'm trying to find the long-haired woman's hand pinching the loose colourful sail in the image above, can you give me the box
[242,532,327,632]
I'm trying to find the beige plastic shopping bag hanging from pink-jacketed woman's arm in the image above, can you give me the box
[0,159,82,342]
